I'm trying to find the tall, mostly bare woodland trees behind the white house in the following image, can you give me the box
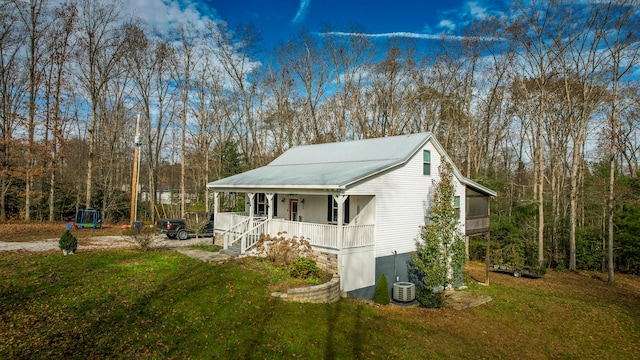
[0,0,640,271]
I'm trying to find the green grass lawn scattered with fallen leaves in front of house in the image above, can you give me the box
[0,251,640,359]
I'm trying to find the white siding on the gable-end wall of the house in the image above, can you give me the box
[347,142,465,257]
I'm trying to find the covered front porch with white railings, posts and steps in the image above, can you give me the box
[214,192,375,254]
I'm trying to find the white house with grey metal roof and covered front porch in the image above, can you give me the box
[207,133,496,299]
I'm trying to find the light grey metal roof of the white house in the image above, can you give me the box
[207,133,495,196]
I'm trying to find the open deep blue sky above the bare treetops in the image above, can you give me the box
[122,0,504,49]
